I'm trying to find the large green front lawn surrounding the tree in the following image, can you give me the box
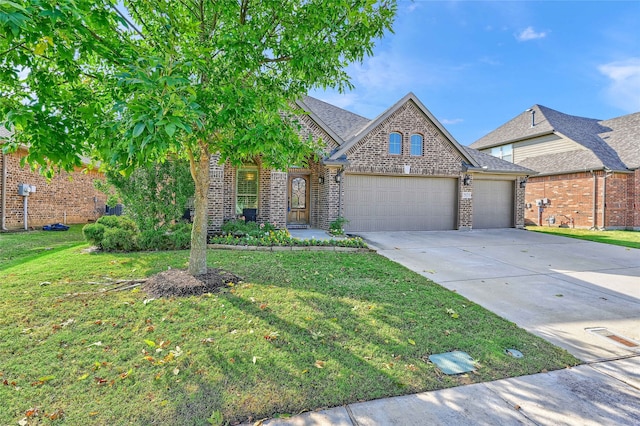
[0,233,579,425]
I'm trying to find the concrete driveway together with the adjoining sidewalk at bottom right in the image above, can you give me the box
[252,229,640,426]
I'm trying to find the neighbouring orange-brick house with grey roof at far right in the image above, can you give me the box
[471,105,640,230]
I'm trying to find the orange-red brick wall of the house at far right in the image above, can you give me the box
[525,170,640,229]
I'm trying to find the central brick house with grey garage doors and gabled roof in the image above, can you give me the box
[208,93,533,232]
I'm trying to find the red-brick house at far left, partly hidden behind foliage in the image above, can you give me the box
[0,126,106,231]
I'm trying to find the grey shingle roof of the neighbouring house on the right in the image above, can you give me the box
[470,105,638,173]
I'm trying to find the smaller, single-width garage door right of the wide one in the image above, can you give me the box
[473,179,514,229]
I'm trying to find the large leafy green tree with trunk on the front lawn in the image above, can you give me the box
[0,0,396,274]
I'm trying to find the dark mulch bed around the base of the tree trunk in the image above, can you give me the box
[142,268,242,297]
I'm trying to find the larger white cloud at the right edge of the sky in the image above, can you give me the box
[598,57,640,112]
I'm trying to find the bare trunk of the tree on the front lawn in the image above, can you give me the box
[189,146,211,275]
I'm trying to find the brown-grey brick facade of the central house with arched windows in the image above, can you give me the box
[209,101,524,231]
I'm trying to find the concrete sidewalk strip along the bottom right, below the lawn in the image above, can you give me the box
[263,356,640,426]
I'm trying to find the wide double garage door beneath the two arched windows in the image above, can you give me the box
[344,175,458,231]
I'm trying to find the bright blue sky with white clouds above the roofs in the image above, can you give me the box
[310,0,640,145]
